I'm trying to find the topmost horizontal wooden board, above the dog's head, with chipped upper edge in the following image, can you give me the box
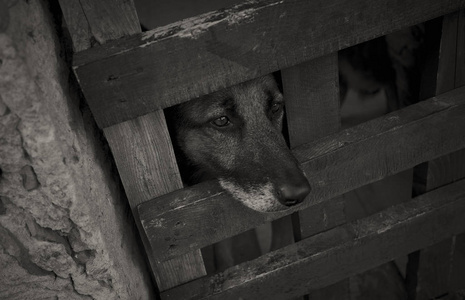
[74,0,465,127]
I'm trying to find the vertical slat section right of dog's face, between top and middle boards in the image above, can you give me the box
[281,53,341,148]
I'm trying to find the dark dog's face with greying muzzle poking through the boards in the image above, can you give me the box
[166,76,310,211]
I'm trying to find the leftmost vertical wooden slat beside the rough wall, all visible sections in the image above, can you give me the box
[60,0,206,291]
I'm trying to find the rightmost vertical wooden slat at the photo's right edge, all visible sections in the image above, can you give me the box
[416,11,465,300]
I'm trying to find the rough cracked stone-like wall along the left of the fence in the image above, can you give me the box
[0,0,153,299]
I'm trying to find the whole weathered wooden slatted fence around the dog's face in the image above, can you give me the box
[60,0,465,299]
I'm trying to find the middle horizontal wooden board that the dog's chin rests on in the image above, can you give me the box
[138,88,465,261]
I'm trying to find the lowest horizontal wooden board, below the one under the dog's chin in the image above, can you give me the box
[162,180,465,300]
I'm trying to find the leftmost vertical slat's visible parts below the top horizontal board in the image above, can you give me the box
[104,110,206,291]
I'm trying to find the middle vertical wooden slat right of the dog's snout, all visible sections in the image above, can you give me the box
[282,53,349,299]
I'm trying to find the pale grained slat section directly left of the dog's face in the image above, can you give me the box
[104,110,183,207]
